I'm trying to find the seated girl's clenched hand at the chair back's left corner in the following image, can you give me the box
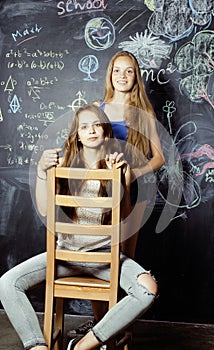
[37,148,62,178]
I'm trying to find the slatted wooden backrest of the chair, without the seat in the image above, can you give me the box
[46,167,121,304]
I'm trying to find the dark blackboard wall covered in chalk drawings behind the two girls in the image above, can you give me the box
[0,0,214,323]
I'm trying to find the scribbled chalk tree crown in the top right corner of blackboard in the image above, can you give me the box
[148,0,214,42]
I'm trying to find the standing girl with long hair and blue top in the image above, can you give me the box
[95,51,164,258]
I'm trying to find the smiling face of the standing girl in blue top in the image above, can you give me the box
[112,56,135,92]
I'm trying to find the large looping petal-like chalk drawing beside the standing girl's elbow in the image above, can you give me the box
[158,121,201,218]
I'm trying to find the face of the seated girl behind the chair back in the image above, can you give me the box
[78,110,104,148]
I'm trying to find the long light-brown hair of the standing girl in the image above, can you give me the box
[104,51,155,166]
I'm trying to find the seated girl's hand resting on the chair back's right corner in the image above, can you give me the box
[105,152,131,186]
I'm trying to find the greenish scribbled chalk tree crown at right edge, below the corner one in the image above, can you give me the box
[174,30,214,107]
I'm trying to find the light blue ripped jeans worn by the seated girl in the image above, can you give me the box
[0,253,155,349]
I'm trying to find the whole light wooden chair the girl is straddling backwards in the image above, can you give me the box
[44,167,131,350]
